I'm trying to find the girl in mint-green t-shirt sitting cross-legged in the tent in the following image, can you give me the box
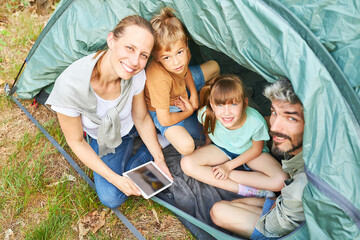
[181,75,287,197]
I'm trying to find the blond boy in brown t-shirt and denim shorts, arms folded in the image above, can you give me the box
[145,7,220,155]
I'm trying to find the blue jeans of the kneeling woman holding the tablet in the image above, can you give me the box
[90,127,153,208]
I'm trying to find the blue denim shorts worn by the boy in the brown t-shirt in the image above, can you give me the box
[149,65,205,139]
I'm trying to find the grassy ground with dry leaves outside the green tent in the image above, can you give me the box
[0,0,194,239]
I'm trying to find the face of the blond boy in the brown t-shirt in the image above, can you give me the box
[154,40,188,74]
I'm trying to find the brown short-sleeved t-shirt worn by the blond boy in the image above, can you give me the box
[145,52,192,111]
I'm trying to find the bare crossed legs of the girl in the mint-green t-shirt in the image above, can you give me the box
[181,144,288,193]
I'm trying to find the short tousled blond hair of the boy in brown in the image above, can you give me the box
[150,7,187,51]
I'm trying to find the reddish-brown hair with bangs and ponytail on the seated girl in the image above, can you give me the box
[200,75,247,134]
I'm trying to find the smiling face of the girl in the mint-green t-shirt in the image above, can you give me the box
[210,99,246,130]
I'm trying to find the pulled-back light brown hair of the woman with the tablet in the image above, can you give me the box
[94,15,155,78]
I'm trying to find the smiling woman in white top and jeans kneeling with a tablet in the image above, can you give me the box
[46,15,171,208]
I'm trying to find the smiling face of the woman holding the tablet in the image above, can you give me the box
[107,25,154,79]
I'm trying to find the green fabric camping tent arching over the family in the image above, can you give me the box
[8,0,360,239]
